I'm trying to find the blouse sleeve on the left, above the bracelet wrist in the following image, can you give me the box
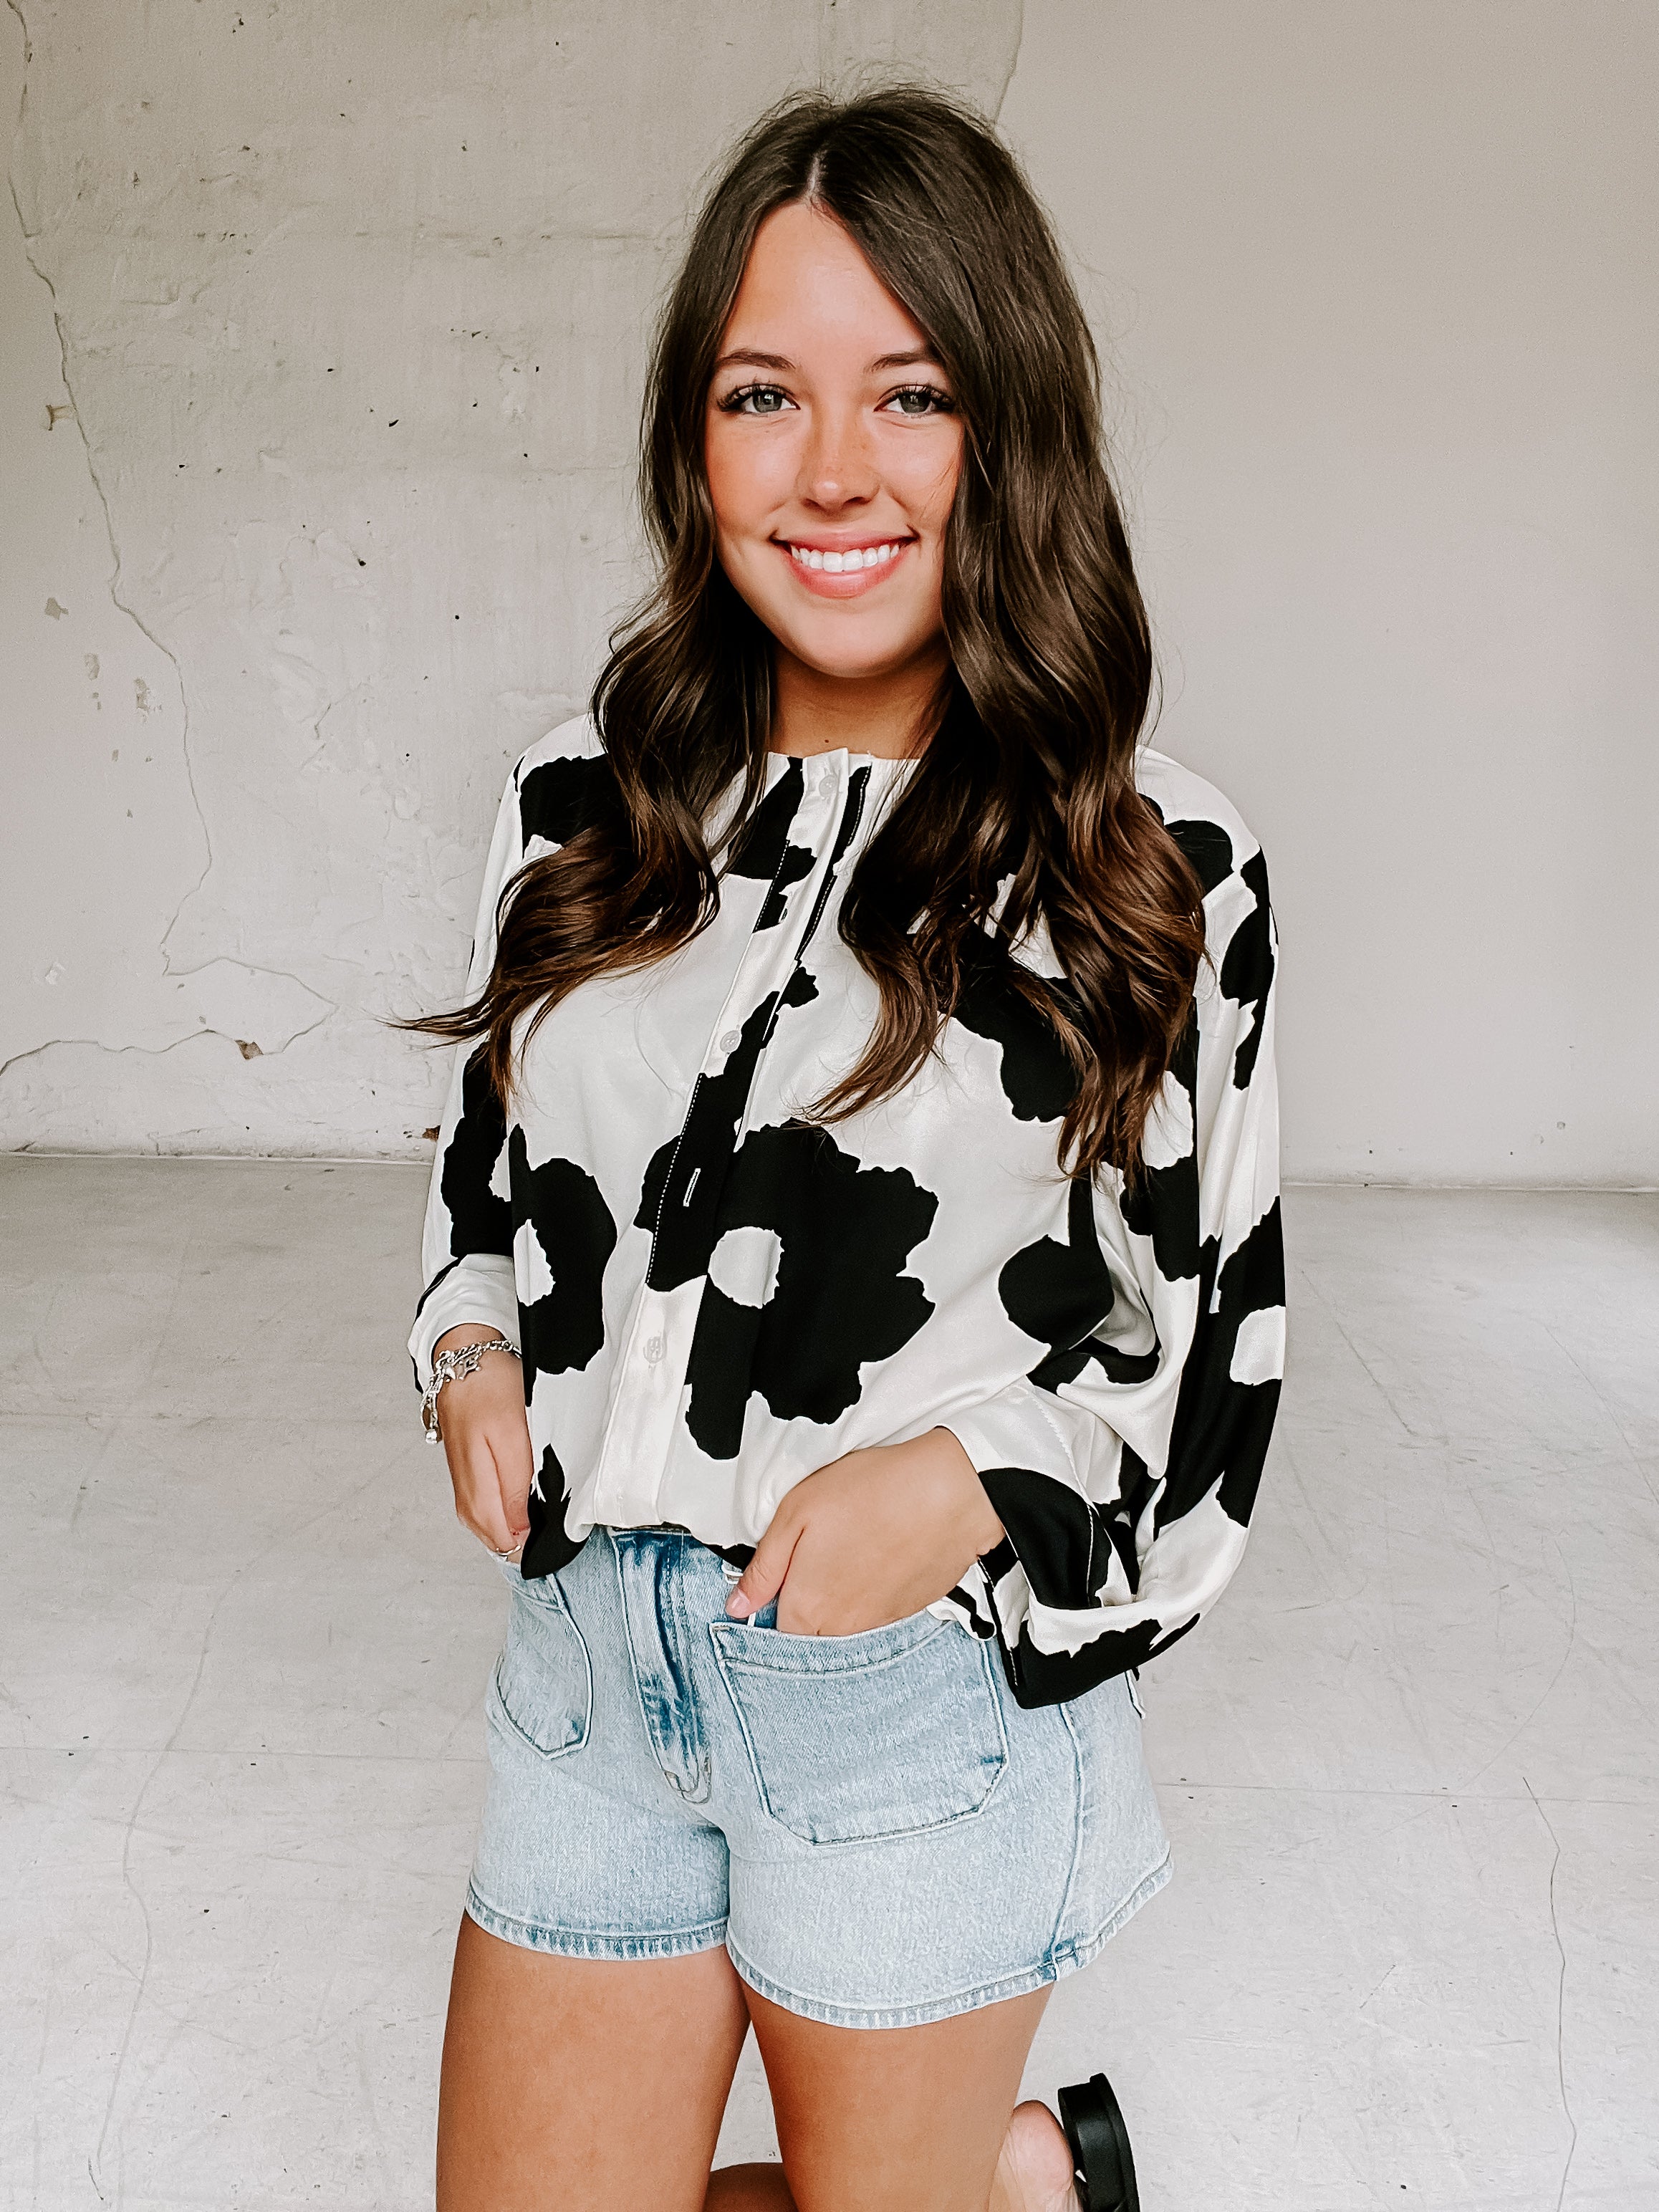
[409,772,524,1385]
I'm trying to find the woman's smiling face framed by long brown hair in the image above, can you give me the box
[703,201,962,750]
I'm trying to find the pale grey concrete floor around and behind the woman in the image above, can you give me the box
[0,1157,1659,2212]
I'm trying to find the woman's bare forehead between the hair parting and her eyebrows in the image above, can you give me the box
[721,201,927,365]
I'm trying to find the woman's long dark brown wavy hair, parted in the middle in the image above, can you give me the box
[411,86,1203,1177]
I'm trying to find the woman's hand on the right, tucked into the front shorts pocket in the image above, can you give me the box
[726,1429,1002,1637]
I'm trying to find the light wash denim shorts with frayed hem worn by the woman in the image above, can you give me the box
[467,1529,1170,2029]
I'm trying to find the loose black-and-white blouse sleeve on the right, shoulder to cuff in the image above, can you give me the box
[945,823,1285,1706]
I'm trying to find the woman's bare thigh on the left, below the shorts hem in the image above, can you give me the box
[438,1920,748,2212]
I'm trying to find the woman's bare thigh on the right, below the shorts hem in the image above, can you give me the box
[746,1989,1049,2212]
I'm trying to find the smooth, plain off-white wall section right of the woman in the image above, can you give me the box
[1002,0,1659,1183]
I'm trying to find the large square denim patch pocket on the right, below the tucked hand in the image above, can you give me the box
[710,1612,1009,1842]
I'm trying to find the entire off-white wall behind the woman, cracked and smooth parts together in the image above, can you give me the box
[0,0,1659,1181]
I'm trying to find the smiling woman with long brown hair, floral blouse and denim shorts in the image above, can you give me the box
[409,77,1283,2212]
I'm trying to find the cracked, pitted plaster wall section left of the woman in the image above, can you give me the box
[0,0,1020,1155]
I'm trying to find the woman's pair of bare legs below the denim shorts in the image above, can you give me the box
[438,1920,1075,2212]
